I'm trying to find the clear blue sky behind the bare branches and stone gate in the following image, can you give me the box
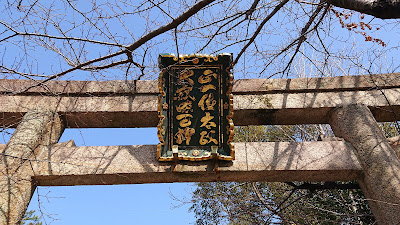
[0,0,400,225]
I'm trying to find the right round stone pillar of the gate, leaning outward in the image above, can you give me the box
[329,104,400,225]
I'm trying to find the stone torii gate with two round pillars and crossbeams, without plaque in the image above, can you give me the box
[0,73,400,224]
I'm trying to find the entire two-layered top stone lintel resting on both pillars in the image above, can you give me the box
[0,73,400,128]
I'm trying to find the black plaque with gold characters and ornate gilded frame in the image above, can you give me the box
[157,53,235,161]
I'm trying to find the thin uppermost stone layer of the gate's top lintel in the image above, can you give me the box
[0,73,400,96]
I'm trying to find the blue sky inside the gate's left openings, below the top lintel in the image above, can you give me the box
[28,128,195,225]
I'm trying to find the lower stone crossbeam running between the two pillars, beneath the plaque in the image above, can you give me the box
[31,141,362,186]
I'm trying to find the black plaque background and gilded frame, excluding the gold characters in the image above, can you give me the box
[157,54,234,161]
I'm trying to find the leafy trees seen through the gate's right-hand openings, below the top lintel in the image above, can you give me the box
[190,125,376,225]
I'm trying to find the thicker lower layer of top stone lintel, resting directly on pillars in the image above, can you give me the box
[0,88,400,128]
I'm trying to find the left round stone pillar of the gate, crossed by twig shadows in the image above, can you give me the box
[0,110,64,225]
